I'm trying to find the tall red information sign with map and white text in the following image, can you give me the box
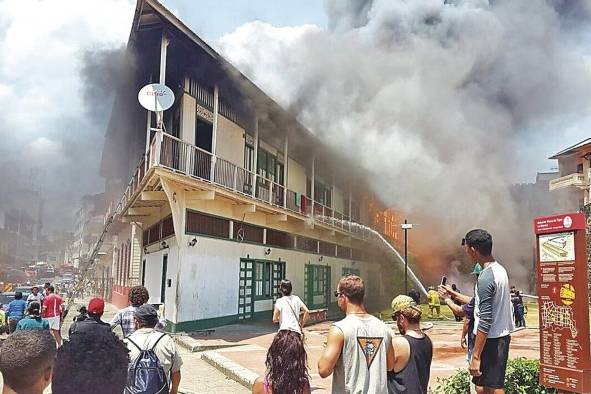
[534,213,591,393]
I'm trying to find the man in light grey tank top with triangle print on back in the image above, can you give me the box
[318,275,394,394]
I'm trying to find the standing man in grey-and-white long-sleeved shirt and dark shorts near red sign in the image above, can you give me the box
[462,229,514,394]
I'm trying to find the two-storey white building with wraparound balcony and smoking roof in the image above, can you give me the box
[95,0,397,331]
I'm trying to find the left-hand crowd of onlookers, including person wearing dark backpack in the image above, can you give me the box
[0,284,183,394]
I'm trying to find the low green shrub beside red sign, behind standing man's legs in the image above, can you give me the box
[430,357,556,394]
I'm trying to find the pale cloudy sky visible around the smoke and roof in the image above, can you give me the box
[0,0,591,234]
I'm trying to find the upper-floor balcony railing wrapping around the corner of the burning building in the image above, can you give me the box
[112,132,363,237]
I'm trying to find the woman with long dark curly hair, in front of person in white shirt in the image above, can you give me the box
[252,330,310,394]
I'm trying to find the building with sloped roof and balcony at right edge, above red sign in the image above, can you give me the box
[549,138,591,209]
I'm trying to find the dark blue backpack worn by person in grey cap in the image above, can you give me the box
[124,334,169,394]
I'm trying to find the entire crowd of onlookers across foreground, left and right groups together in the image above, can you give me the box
[0,226,519,394]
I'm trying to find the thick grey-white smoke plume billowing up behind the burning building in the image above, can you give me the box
[219,0,591,284]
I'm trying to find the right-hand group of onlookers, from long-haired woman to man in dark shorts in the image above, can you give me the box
[252,229,514,394]
